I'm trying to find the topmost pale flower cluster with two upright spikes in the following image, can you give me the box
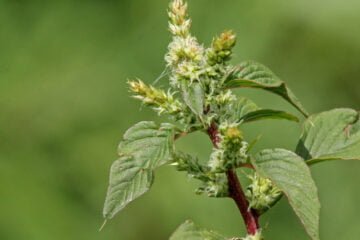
[165,0,236,88]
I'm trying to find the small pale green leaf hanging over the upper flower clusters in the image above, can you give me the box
[181,82,204,119]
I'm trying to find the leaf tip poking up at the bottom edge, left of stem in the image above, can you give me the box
[170,220,226,240]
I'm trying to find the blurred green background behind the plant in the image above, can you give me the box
[0,0,360,240]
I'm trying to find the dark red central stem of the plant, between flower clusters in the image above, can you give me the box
[207,123,260,235]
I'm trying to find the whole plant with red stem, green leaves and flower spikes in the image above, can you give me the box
[104,0,360,240]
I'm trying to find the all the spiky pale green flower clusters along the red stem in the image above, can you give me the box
[129,0,281,218]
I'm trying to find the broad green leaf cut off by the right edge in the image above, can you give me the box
[296,108,360,164]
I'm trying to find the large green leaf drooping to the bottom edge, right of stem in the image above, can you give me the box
[252,149,320,240]
